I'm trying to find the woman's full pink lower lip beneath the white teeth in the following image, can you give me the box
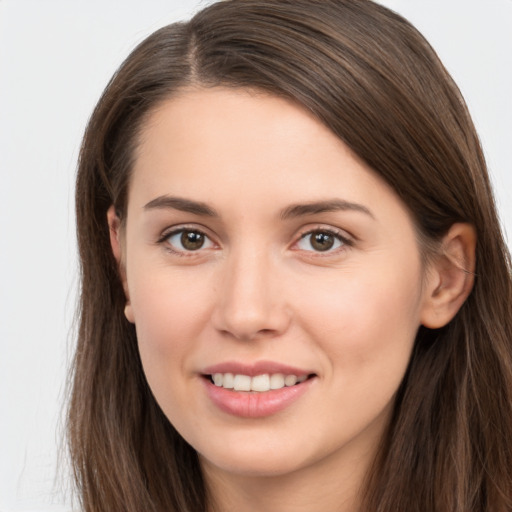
[203,378,315,418]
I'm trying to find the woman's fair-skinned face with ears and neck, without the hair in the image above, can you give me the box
[108,88,474,512]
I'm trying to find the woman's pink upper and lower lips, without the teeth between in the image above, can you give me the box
[202,361,316,418]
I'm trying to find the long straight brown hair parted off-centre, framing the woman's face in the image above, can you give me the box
[68,0,512,512]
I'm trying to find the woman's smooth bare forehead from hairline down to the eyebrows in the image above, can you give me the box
[130,87,403,225]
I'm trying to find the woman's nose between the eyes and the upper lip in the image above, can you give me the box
[212,246,292,341]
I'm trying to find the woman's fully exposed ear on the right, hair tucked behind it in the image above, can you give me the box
[421,223,476,329]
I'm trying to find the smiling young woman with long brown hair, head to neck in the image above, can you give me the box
[69,0,512,512]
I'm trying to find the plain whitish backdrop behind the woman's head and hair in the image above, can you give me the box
[0,0,512,512]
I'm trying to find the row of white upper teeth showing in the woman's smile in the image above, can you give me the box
[211,373,308,393]
